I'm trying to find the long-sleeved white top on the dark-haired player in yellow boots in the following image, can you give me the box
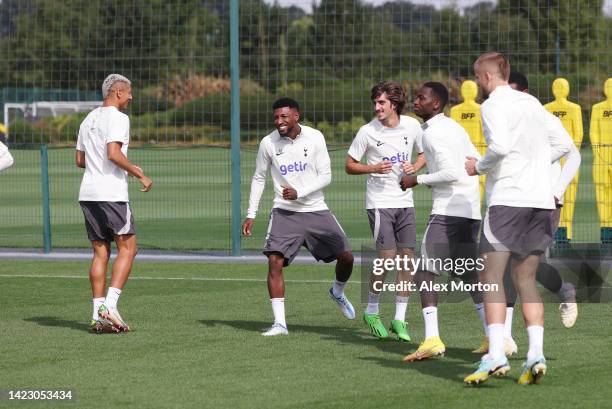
[417,113,481,220]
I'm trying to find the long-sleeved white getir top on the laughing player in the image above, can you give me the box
[247,124,331,219]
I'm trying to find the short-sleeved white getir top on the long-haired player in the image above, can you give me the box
[348,115,423,209]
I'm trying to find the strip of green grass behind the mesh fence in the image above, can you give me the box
[0,147,599,251]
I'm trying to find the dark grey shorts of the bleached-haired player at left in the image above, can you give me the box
[79,202,136,241]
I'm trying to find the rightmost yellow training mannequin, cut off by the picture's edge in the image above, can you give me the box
[589,78,612,244]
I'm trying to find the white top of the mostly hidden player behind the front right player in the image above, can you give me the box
[546,111,581,203]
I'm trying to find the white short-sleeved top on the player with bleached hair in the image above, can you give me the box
[77,107,130,202]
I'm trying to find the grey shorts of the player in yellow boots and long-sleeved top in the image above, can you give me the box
[421,214,480,276]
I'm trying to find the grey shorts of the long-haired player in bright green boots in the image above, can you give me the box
[368,207,416,250]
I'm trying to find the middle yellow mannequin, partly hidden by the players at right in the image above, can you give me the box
[544,78,584,240]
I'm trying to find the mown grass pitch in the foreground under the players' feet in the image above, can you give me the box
[0,261,612,408]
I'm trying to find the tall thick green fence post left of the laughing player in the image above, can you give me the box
[230,0,242,256]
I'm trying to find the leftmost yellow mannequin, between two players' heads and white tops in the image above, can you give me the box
[451,80,487,202]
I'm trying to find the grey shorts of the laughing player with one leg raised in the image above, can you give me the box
[263,209,351,266]
